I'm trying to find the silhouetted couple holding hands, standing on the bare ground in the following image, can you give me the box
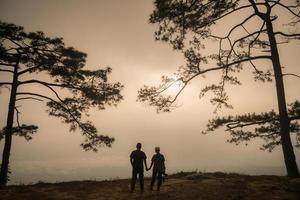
[130,143,167,192]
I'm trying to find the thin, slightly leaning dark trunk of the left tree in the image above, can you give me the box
[0,61,19,186]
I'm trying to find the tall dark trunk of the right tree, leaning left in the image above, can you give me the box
[265,16,299,177]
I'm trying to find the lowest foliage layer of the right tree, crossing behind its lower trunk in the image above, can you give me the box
[203,101,300,152]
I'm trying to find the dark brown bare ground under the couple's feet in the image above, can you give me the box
[0,172,300,200]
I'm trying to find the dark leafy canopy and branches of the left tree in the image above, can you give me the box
[0,22,123,151]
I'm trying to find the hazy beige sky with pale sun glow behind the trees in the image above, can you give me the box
[0,0,300,183]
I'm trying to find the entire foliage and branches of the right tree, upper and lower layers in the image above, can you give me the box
[138,0,300,151]
